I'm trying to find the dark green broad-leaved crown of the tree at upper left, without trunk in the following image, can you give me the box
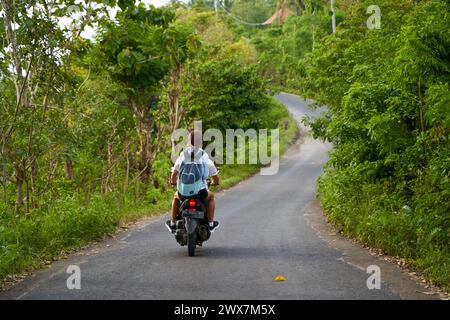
[95,4,174,95]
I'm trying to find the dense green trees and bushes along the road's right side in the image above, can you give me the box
[299,1,450,286]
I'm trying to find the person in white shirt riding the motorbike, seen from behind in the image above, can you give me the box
[166,130,219,233]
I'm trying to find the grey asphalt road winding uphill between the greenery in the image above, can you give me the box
[0,94,426,299]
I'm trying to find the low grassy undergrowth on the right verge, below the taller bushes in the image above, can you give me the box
[318,167,450,290]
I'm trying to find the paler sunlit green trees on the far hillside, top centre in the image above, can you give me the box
[223,0,332,90]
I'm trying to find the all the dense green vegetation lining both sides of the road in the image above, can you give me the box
[0,0,450,288]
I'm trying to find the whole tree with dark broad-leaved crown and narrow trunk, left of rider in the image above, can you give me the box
[95,4,174,182]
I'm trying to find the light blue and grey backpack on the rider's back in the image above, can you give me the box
[177,150,206,197]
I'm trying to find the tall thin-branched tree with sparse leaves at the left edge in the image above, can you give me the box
[0,0,111,213]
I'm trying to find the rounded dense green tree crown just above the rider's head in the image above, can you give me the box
[184,58,269,130]
